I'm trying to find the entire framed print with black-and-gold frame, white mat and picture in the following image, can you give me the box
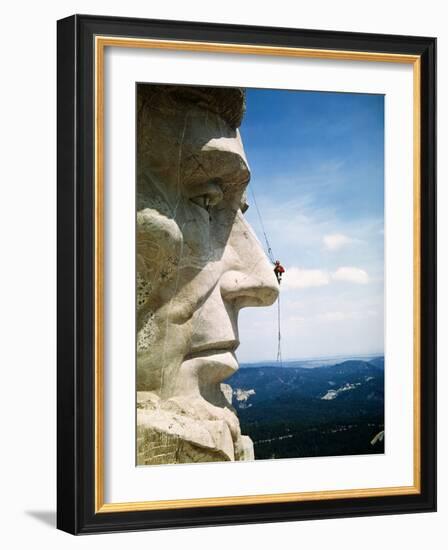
[58,15,436,534]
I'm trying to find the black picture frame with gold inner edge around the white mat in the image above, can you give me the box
[58,16,436,534]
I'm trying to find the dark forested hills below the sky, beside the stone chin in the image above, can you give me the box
[227,357,384,464]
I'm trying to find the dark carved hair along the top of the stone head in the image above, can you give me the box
[137,84,246,130]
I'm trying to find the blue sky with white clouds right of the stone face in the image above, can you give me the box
[237,89,384,362]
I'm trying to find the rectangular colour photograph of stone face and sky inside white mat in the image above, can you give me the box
[135,82,384,466]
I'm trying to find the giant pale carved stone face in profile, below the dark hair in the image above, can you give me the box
[137,87,278,464]
